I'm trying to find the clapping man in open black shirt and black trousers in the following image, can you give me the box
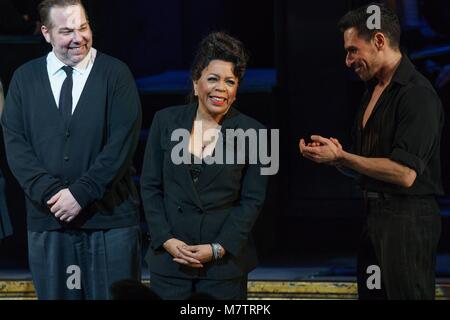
[300,6,444,299]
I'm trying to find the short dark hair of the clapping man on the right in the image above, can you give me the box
[338,3,401,49]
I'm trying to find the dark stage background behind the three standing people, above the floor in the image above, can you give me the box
[0,0,450,266]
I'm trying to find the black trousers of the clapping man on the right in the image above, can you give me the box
[358,195,441,300]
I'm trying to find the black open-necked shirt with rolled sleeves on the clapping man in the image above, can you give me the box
[353,55,444,195]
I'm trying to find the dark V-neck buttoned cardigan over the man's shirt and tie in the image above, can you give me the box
[2,52,141,231]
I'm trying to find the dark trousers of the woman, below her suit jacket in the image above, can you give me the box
[150,272,247,300]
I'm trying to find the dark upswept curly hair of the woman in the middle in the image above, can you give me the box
[191,32,248,82]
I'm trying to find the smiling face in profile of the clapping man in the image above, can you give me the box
[344,28,380,81]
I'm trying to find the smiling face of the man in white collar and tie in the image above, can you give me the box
[41,5,92,67]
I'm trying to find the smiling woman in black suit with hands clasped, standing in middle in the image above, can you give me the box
[141,32,267,299]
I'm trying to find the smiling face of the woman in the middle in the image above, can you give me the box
[193,60,238,121]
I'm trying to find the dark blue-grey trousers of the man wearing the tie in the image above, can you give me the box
[28,226,141,300]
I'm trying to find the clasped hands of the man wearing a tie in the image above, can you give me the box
[47,189,81,222]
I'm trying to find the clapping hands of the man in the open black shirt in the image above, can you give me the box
[299,135,343,165]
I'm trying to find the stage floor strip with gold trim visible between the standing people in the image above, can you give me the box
[0,254,450,300]
